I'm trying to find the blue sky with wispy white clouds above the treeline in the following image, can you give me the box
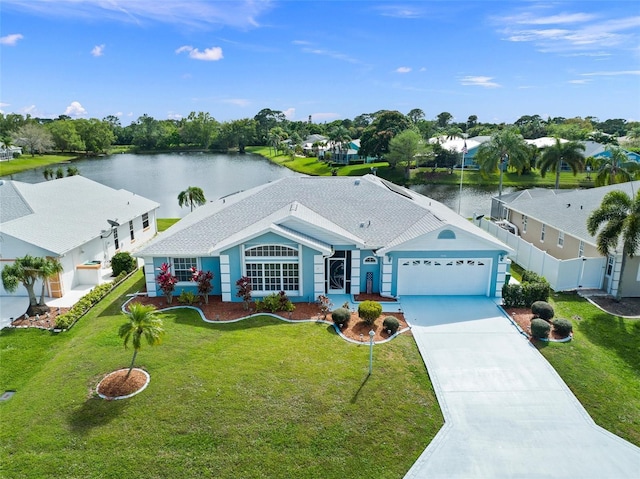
[0,0,640,125]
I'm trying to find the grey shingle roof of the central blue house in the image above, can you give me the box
[137,175,509,256]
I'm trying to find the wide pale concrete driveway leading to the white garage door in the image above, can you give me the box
[401,296,640,479]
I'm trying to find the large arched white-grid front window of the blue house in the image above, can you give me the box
[244,245,300,293]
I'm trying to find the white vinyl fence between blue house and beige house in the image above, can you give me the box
[476,218,606,291]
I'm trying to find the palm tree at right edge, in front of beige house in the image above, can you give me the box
[587,190,640,299]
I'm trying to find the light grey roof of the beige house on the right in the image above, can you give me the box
[500,181,640,245]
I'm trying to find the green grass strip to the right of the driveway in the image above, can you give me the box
[538,293,640,446]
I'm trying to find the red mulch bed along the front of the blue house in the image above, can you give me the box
[129,296,408,342]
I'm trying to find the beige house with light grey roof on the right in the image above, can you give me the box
[491,181,640,297]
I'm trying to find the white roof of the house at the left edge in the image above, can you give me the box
[0,176,160,255]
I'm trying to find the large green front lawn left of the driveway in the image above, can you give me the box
[0,274,442,478]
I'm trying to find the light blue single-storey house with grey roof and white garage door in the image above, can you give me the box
[136,175,511,302]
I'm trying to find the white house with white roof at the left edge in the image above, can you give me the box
[0,175,160,297]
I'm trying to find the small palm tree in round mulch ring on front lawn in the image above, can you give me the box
[118,303,164,378]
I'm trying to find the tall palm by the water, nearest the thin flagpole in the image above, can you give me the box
[476,129,530,197]
